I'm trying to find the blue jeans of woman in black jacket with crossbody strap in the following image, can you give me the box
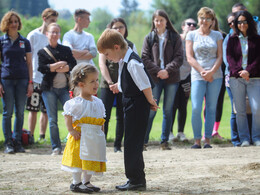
[42,87,70,149]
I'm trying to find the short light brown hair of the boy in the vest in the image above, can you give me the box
[97,29,127,53]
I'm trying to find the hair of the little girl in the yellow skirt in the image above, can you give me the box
[70,63,98,97]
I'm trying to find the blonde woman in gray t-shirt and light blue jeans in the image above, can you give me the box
[186,7,223,149]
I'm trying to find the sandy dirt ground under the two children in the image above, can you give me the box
[0,143,260,195]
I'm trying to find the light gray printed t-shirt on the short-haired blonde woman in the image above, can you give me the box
[186,29,223,82]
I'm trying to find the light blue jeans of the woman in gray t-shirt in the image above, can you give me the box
[191,78,222,139]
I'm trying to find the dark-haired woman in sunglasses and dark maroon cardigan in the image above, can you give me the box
[227,11,260,147]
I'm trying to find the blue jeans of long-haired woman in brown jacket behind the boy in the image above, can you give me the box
[144,80,179,144]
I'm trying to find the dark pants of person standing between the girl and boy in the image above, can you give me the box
[100,88,124,147]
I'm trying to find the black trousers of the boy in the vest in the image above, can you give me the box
[123,95,150,184]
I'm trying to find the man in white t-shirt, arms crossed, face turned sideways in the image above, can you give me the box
[62,9,97,65]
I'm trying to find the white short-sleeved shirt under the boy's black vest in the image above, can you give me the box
[117,47,151,92]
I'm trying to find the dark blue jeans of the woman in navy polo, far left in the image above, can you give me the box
[1,79,28,145]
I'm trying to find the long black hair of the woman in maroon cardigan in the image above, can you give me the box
[234,10,257,37]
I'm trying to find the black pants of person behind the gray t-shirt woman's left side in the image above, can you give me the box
[171,75,191,132]
